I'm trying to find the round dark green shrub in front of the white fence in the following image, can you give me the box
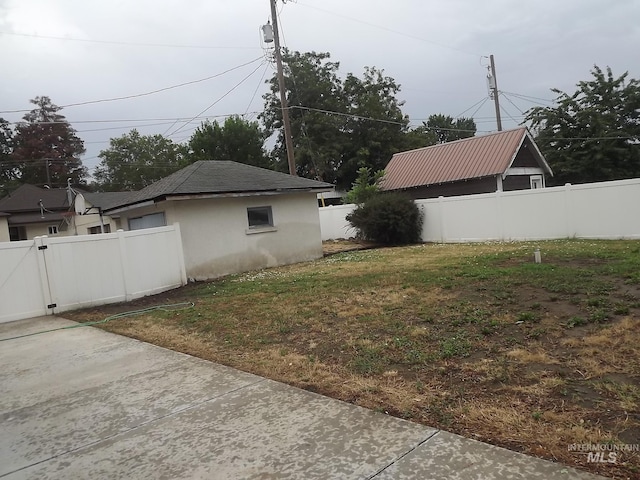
[346,193,422,245]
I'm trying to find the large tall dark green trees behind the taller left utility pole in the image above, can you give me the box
[261,51,408,188]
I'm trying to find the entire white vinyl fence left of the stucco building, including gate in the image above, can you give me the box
[0,224,187,323]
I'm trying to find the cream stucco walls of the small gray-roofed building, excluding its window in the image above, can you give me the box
[115,193,322,280]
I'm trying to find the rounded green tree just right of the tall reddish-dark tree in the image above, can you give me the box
[94,129,186,191]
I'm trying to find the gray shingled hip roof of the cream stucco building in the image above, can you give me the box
[105,160,333,210]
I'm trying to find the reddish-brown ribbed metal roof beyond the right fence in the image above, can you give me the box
[382,127,533,190]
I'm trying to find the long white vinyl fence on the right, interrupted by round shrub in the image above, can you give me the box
[320,179,640,242]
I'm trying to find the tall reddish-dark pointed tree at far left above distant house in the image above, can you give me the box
[11,96,87,187]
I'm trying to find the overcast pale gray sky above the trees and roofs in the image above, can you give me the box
[0,0,640,174]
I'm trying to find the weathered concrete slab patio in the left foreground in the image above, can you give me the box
[0,317,601,480]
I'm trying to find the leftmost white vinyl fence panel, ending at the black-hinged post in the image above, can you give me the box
[0,240,47,323]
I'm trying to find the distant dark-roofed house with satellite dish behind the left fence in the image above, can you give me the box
[0,184,129,242]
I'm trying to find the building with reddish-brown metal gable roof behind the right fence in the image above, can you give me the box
[381,127,553,199]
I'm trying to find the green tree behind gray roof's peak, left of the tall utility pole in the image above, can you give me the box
[189,115,271,168]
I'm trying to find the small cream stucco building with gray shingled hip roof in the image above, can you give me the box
[104,161,333,280]
